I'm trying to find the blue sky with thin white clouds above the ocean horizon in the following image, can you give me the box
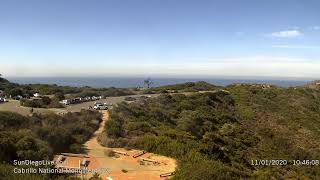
[0,0,320,78]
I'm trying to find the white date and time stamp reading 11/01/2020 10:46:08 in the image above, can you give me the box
[251,159,320,166]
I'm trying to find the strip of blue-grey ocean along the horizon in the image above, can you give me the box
[7,77,311,88]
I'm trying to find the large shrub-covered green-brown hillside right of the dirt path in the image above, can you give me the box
[103,85,320,180]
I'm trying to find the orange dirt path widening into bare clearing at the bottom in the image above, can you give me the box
[84,111,176,180]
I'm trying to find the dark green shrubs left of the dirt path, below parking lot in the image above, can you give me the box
[0,110,101,179]
